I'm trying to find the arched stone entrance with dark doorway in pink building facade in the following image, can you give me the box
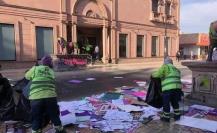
[73,0,109,59]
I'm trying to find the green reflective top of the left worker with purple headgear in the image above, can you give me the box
[25,66,57,100]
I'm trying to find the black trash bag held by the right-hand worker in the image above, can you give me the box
[145,78,163,108]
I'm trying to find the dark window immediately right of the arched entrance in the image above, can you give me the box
[119,34,127,58]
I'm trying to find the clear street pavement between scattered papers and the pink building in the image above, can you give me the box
[1,61,191,101]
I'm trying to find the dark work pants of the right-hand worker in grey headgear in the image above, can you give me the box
[163,89,182,115]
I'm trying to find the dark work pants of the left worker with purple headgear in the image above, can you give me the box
[31,98,61,131]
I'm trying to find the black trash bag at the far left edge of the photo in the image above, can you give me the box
[0,77,15,121]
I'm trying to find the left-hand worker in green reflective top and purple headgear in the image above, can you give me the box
[25,56,65,133]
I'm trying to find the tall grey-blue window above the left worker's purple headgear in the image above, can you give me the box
[36,27,53,59]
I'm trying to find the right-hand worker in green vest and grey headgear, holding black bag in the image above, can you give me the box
[152,57,182,122]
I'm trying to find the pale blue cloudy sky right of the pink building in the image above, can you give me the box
[180,0,217,33]
